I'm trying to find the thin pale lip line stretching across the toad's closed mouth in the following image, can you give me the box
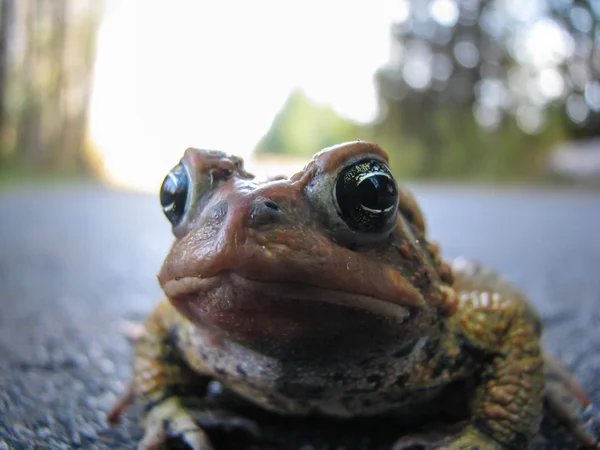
[164,271,410,321]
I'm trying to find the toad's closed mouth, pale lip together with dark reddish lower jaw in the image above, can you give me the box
[163,271,420,340]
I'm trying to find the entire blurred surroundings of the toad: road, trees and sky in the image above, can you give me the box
[0,0,600,450]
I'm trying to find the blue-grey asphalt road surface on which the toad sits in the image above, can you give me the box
[0,185,600,450]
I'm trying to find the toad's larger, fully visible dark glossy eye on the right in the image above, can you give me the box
[334,159,398,233]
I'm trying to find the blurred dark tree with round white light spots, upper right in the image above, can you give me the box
[375,0,600,178]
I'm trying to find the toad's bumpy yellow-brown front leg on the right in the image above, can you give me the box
[395,292,544,450]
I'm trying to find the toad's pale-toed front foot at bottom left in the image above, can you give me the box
[143,397,259,450]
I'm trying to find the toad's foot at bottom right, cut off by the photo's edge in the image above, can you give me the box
[393,427,506,450]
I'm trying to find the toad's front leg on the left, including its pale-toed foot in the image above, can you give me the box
[115,302,256,450]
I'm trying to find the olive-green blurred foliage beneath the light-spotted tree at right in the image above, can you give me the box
[374,102,567,180]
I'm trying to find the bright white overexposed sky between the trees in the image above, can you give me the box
[91,0,406,190]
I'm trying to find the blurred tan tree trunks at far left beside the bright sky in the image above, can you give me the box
[0,0,102,173]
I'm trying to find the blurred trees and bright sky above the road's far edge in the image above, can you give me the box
[0,0,600,191]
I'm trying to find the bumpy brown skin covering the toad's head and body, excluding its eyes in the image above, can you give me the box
[110,142,596,450]
